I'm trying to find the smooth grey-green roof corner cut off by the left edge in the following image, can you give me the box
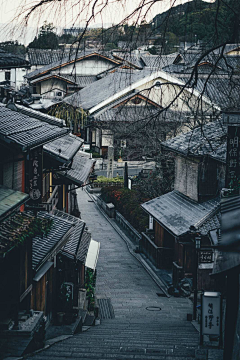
[0,185,29,220]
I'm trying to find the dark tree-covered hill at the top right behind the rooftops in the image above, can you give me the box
[153,0,240,44]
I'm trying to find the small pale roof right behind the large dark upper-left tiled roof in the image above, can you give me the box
[43,134,83,161]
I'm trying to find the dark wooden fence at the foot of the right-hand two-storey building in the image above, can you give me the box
[140,233,173,269]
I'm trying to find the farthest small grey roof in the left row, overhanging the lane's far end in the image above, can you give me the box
[59,153,95,186]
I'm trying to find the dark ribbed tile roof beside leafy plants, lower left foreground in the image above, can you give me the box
[32,211,74,271]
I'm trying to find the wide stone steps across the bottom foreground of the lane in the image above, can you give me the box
[30,318,202,360]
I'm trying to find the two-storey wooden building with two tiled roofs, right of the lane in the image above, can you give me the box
[142,120,226,290]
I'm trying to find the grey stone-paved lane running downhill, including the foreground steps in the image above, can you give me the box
[27,190,202,360]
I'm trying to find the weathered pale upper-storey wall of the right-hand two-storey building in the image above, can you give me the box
[174,156,198,201]
